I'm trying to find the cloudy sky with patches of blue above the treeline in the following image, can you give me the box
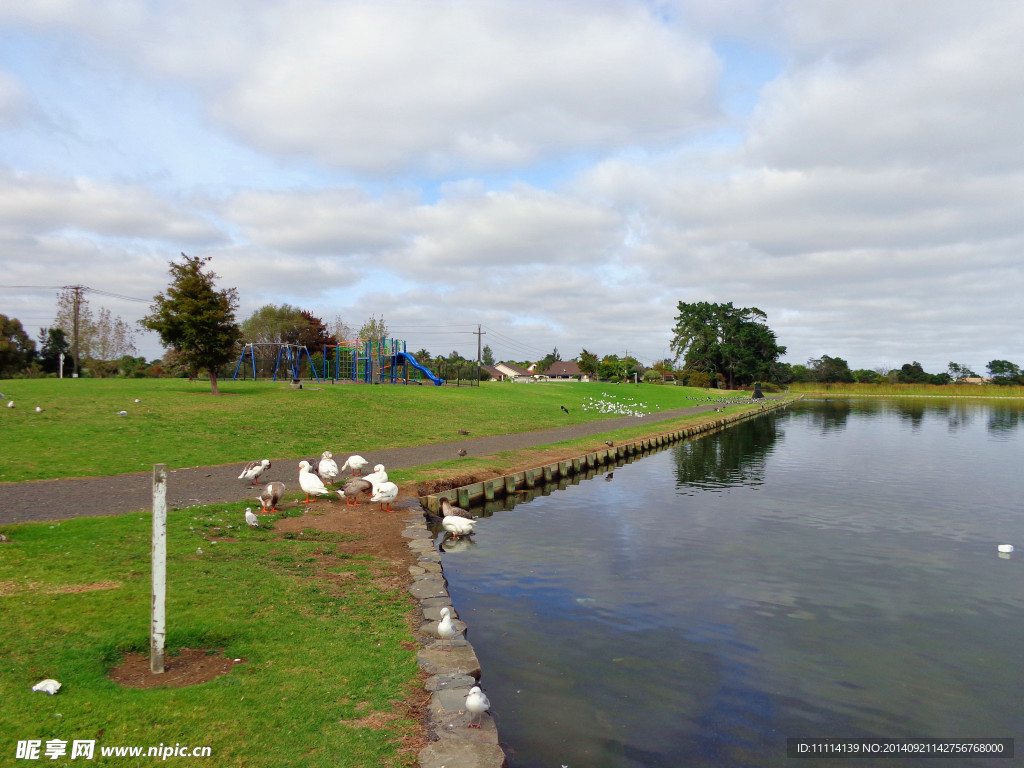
[0,0,1024,373]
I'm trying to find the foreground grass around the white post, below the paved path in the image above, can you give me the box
[0,505,418,768]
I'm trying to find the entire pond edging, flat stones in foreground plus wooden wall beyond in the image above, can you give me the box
[401,399,793,768]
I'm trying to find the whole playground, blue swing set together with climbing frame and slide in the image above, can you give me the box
[231,339,464,387]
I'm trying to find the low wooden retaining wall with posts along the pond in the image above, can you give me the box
[420,399,793,514]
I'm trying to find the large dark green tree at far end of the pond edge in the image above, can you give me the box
[672,301,785,389]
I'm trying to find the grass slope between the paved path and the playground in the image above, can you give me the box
[0,379,741,482]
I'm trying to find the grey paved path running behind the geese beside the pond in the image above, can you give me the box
[0,403,737,524]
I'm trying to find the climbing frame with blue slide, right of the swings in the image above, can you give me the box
[324,339,444,387]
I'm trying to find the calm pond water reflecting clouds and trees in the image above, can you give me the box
[442,400,1024,768]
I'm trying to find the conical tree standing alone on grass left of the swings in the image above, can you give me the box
[139,254,242,394]
